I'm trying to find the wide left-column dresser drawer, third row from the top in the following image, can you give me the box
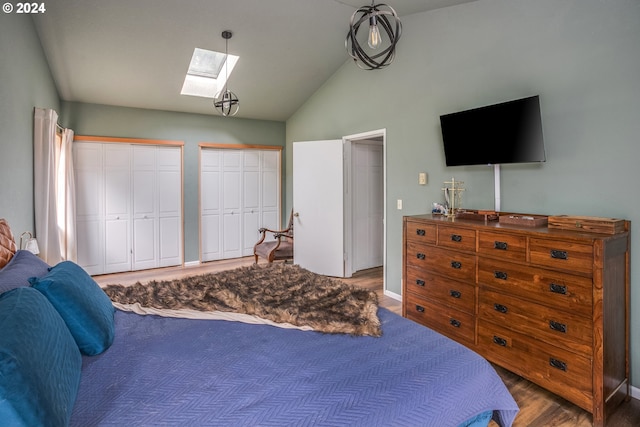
[406,267,476,314]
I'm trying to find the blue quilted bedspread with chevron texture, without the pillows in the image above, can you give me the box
[71,308,517,427]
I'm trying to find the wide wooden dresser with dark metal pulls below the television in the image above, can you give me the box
[402,215,630,426]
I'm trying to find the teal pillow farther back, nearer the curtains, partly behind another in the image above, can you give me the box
[30,261,115,356]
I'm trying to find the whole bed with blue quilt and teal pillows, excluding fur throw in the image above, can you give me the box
[0,221,518,427]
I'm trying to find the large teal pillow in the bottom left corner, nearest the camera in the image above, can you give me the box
[0,287,82,426]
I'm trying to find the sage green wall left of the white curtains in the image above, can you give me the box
[0,13,60,237]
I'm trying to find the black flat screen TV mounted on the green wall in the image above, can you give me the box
[440,95,546,166]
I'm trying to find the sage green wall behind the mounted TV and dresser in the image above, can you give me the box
[285,0,640,387]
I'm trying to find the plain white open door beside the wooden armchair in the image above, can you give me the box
[293,140,344,277]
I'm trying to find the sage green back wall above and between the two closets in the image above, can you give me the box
[62,102,285,262]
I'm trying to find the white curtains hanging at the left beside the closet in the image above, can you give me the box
[33,108,77,265]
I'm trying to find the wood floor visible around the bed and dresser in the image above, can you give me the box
[94,257,640,427]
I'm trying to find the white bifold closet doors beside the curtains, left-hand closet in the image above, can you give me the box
[74,142,183,274]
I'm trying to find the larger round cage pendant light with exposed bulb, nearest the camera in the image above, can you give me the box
[344,0,402,70]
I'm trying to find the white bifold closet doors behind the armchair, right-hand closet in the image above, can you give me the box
[200,148,280,261]
